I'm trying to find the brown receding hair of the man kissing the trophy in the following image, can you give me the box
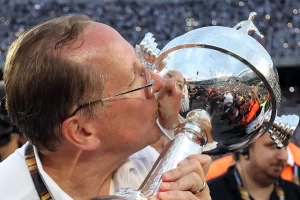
[4,15,103,151]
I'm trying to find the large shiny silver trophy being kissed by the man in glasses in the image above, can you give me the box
[95,13,299,200]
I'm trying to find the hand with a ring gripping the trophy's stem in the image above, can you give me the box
[153,155,211,200]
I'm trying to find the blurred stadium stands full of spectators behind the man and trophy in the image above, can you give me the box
[0,0,300,146]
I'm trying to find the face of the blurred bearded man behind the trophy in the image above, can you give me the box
[249,133,288,180]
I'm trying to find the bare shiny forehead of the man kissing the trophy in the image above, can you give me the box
[58,22,137,95]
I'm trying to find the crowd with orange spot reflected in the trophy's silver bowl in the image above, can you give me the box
[189,85,268,126]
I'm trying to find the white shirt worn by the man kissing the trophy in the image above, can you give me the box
[0,143,159,200]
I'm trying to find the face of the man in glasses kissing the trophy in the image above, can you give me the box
[66,23,162,153]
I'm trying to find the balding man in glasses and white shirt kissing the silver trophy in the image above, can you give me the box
[0,15,210,200]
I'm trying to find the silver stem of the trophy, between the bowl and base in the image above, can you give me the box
[139,113,207,198]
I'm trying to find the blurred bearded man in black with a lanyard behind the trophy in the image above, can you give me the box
[208,133,300,200]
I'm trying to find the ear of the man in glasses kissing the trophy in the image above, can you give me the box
[62,115,100,151]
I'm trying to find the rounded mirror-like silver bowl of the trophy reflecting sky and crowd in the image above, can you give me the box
[151,26,281,155]
